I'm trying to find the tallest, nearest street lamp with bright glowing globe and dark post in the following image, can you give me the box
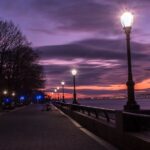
[120,12,140,111]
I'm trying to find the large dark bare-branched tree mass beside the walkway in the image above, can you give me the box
[0,21,43,94]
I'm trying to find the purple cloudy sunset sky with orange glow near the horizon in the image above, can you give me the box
[0,0,150,97]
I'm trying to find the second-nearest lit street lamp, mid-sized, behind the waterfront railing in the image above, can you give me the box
[71,69,78,104]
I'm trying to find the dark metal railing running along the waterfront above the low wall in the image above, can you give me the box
[52,101,150,132]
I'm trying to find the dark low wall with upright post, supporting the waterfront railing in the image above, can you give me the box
[59,107,150,150]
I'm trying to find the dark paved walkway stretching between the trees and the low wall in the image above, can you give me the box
[0,105,118,150]
